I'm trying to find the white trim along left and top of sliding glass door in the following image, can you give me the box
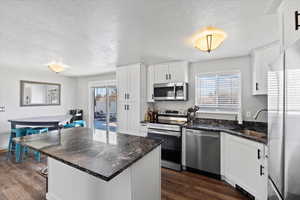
[88,80,117,129]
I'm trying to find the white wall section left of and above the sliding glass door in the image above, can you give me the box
[77,72,116,124]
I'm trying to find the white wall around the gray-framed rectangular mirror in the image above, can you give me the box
[0,66,77,149]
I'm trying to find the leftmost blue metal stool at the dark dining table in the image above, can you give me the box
[8,127,28,162]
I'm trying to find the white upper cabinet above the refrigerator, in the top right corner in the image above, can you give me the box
[279,0,300,49]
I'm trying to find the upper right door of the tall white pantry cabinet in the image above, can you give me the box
[127,64,140,101]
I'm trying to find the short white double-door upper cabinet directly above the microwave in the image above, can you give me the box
[154,62,188,83]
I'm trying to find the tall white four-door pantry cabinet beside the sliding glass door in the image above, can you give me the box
[117,64,146,135]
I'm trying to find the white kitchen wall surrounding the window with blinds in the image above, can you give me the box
[156,56,267,122]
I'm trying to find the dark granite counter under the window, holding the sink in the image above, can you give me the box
[185,122,268,144]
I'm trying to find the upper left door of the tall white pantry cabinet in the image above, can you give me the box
[117,67,128,101]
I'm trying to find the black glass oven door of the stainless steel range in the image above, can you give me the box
[148,129,181,170]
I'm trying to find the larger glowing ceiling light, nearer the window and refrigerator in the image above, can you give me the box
[194,26,227,52]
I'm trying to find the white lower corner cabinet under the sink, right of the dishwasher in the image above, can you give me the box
[221,133,268,200]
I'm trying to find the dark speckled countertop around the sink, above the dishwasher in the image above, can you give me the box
[185,120,268,144]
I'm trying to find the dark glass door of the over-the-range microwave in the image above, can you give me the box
[154,83,175,100]
